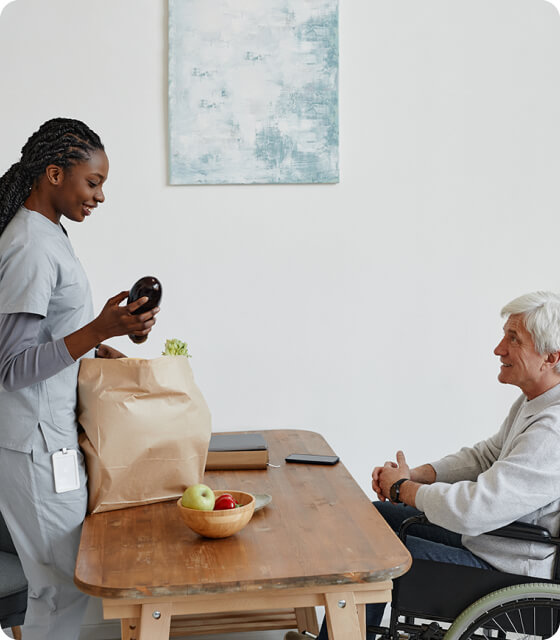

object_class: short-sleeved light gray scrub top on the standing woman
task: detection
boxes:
[0,207,94,453]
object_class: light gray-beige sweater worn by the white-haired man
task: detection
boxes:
[416,385,560,578]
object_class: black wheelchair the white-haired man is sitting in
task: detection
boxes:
[367,514,560,640]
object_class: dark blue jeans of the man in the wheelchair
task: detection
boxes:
[318,501,492,640]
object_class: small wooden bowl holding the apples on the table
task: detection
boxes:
[177,490,255,538]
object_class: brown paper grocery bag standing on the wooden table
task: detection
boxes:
[78,356,211,513]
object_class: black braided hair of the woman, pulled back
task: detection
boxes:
[0,118,104,235]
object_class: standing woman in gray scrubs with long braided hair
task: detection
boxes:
[0,118,159,640]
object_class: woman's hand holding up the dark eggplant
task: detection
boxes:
[92,291,159,342]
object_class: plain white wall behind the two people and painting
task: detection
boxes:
[0,0,560,636]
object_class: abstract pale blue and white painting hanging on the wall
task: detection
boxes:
[169,0,339,184]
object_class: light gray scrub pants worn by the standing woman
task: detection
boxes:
[0,427,89,640]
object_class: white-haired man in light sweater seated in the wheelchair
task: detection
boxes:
[286,291,560,640]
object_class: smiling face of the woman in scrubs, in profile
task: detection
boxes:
[52,149,109,222]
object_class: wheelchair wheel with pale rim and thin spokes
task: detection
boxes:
[444,583,560,640]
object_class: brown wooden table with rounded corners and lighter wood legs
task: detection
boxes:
[75,430,411,640]
